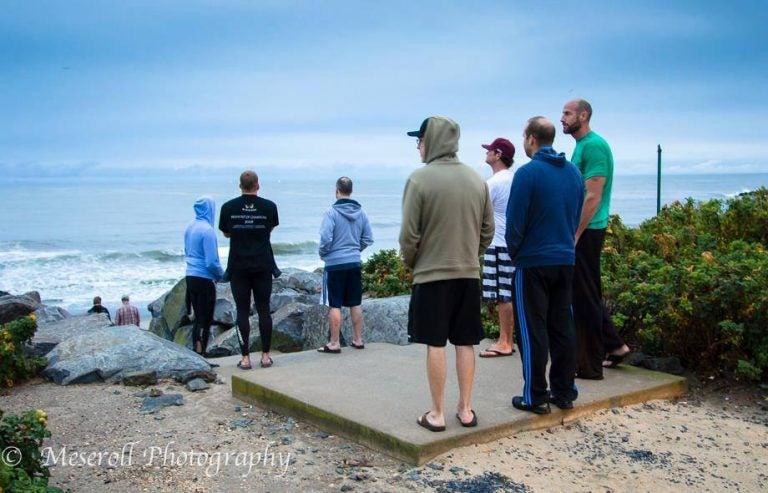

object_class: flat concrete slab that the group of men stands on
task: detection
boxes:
[232,341,686,465]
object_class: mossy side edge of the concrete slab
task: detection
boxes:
[232,365,687,466]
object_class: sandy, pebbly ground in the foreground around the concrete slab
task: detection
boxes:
[0,363,768,493]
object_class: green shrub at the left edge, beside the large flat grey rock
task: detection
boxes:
[0,314,45,387]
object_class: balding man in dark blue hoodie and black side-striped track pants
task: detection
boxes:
[505,116,584,414]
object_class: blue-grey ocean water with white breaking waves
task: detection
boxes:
[0,169,768,318]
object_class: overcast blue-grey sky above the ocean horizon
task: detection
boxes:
[0,0,768,175]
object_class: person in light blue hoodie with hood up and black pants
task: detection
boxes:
[184,196,224,355]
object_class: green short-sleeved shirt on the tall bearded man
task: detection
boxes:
[571,132,613,229]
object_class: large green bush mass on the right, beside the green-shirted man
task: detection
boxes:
[603,188,768,380]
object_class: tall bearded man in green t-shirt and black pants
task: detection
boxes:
[560,99,629,380]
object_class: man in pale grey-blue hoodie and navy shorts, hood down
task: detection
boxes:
[318,176,373,354]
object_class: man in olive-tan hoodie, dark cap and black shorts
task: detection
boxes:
[400,116,494,431]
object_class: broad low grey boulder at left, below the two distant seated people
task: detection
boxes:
[43,326,216,385]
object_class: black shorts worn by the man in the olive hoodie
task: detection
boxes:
[408,279,485,347]
